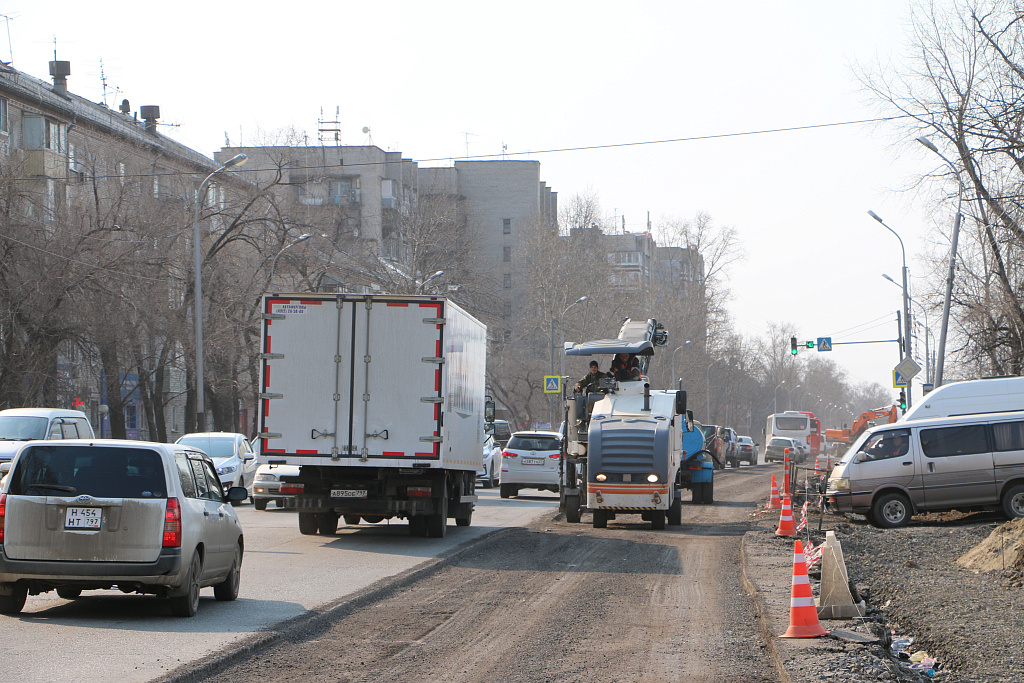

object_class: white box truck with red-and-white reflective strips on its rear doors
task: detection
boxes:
[257,294,494,538]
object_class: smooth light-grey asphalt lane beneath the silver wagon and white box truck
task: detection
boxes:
[0,489,557,683]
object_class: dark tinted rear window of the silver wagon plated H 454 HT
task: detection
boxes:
[8,445,167,498]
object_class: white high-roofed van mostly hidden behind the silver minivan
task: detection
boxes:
[900,377,1024,422]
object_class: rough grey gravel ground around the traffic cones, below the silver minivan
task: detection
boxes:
[748,513,1024,683]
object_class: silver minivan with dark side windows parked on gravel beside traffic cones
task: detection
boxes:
[825,412,1024,528]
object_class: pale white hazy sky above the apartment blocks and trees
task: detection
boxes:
[0,0,953,395]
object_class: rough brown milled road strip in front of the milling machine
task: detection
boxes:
[180,467,779,683]
